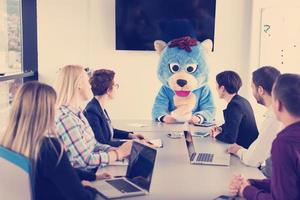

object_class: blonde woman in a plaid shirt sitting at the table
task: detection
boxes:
[56,65,132,171]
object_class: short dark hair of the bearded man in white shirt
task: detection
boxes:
[252,66,280,95]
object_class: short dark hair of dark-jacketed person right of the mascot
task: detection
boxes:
[216,71,242,94]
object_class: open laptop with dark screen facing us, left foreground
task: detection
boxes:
[93,142,156,199]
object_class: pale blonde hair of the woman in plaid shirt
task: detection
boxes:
[55,65,85,107]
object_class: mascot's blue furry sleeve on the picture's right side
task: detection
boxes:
[193,86,216,122]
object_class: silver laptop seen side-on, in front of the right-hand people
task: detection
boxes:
[184,131,230,166]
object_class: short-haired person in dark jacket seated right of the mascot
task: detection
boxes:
[211,71,258,149]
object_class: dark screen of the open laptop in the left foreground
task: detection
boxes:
[126,142,156,191]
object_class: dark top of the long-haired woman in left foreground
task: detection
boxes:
[34,138,96,200]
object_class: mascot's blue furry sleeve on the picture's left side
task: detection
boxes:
[152,87,170,121]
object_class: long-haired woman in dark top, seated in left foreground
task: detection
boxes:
[0,82,103,200]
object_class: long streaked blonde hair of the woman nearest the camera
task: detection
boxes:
[0,82,56,161]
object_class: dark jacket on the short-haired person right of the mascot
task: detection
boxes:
[216,95,258,149]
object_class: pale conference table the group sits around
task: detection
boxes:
[98,120,264,200]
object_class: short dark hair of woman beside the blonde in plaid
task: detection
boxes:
[90,69,115,96]
